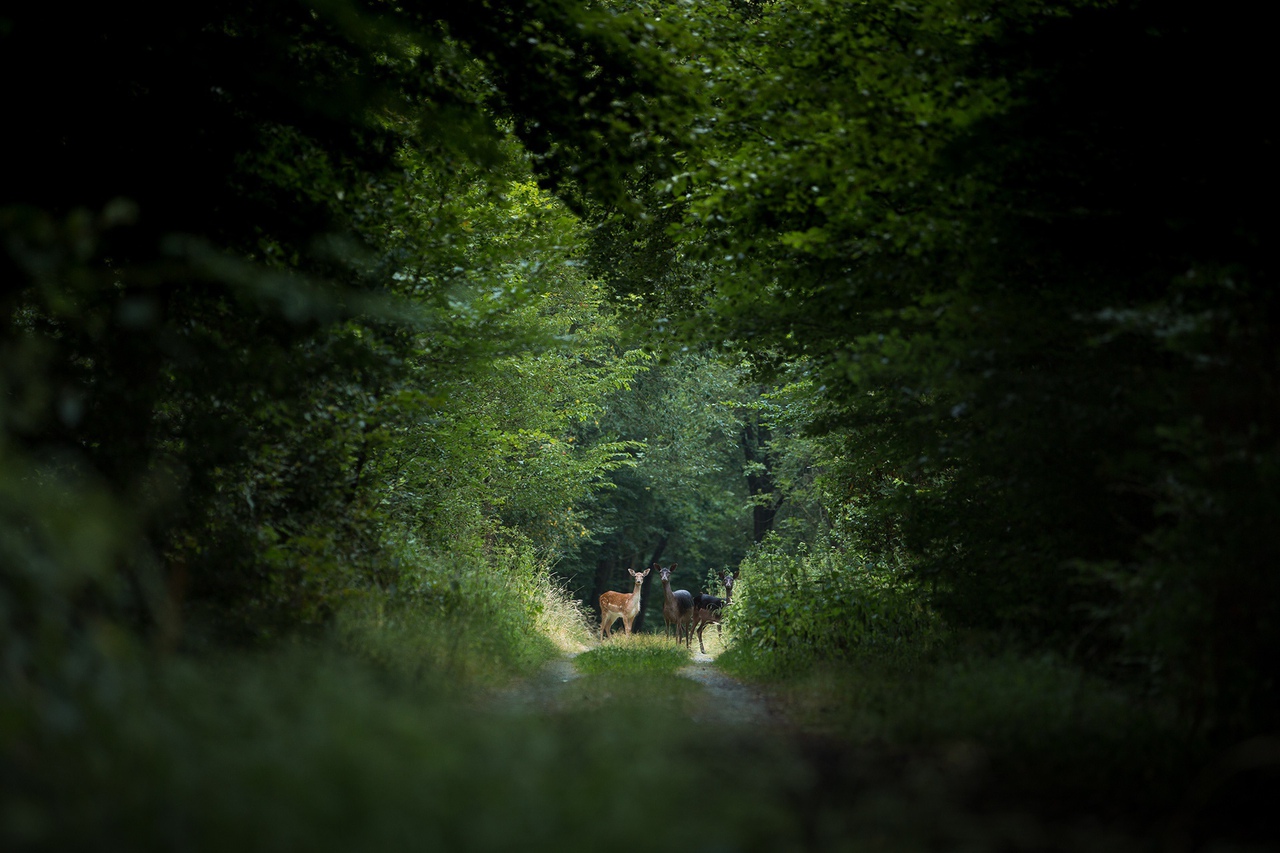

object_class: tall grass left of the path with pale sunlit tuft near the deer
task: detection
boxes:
[0,535,622,852]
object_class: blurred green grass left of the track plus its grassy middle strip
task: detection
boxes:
[0,638,800,853]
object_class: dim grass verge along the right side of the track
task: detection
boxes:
[722,637,1201,816]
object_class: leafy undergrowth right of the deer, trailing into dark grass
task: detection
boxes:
[717,542,1203,811]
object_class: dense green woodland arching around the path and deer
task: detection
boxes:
[0,0,1280,849]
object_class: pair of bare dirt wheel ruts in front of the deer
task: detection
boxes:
[483,647,1158,853]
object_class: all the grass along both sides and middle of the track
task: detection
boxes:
[0,545,1228,853]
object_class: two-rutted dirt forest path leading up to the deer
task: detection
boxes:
[486,646,1156,853]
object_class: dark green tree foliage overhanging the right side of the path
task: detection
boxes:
[664,0,1280,730]
